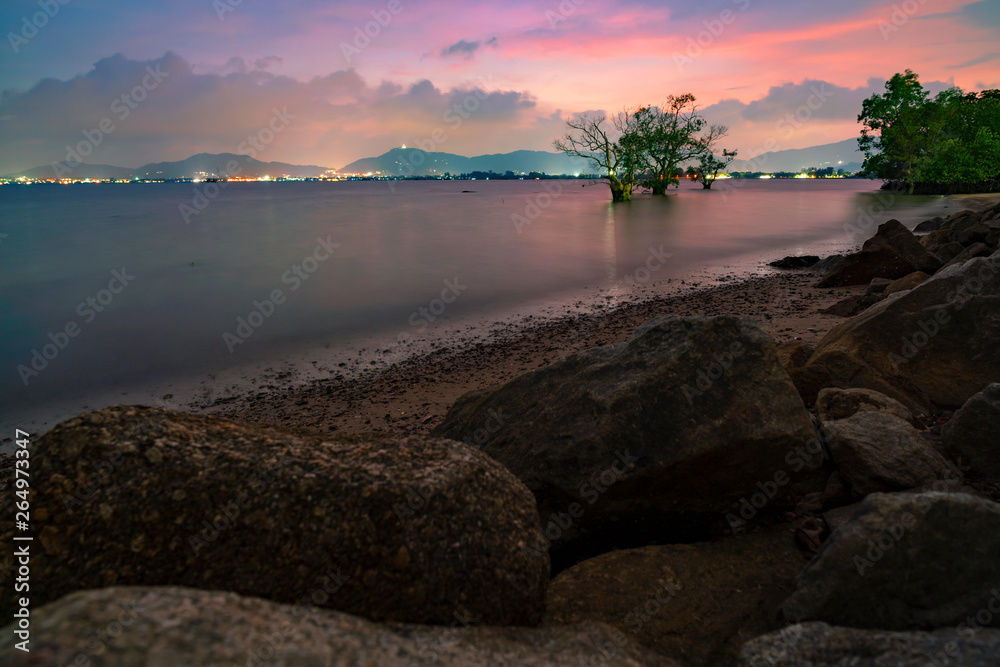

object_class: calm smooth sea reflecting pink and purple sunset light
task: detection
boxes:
[0,180,961,437]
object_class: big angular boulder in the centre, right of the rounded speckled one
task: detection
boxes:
[434,316,822,562]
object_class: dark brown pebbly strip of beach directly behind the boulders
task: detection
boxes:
[201,268,865,435]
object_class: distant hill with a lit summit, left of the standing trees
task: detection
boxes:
[340,148,594,176]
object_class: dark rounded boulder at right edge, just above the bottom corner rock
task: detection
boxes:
[783,491,1000,630]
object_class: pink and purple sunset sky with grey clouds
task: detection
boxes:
[0,0,1000,174]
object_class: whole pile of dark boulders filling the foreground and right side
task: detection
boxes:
[0,206,1000,667]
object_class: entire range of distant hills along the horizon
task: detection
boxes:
[4,139,864,179]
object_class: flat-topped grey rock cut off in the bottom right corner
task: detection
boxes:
[738,623,1000,667]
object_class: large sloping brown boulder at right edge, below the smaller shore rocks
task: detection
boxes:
[798,252,1000,412]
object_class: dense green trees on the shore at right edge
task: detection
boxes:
[858,70,1000,193]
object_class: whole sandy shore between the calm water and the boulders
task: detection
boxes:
[0,189,996,448]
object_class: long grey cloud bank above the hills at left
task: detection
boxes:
[0,52,545,173]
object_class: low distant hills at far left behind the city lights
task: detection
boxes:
[3,153,329,179]
